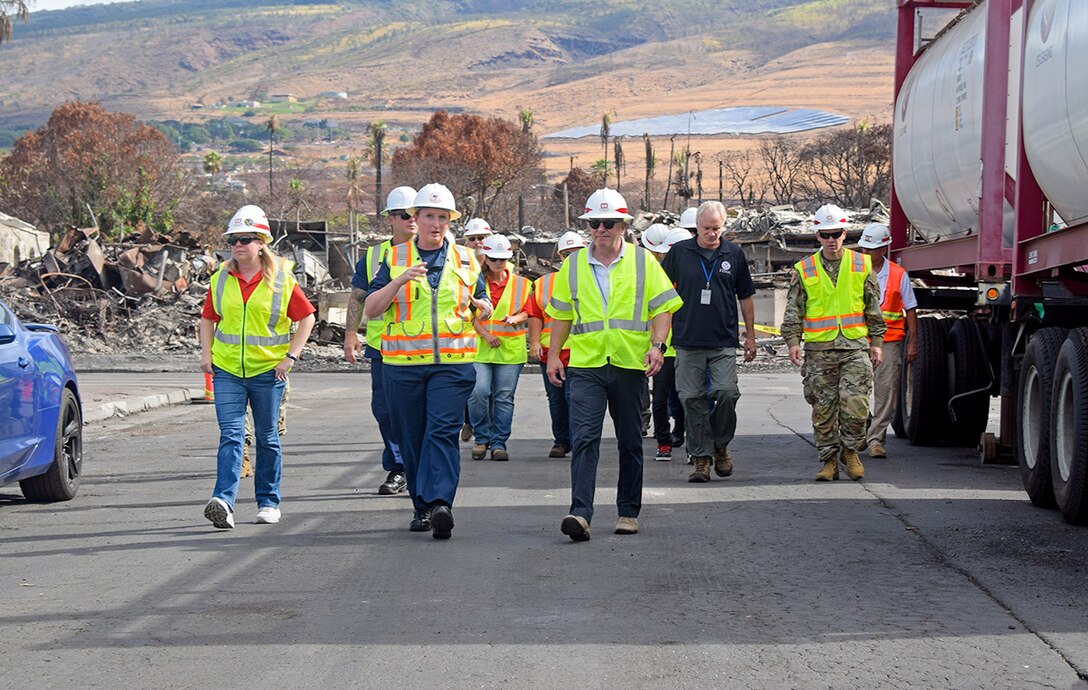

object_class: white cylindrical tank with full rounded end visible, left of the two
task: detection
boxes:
[892,2,1022,245]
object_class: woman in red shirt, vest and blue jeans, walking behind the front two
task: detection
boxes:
[469,234,532,460]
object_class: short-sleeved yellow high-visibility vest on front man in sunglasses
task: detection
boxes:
[547,243,683,371]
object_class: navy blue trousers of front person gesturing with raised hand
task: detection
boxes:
[384,365,475,510]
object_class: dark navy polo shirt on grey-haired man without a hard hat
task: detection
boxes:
[662,238,755,348]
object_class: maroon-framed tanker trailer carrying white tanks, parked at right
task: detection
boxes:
[892,0,1088,523]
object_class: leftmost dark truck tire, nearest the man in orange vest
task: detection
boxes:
[900,317,949,445]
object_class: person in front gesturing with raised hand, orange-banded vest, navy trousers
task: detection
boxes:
[366,183,492,539]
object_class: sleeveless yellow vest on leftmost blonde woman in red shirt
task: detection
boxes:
[211,260,295,379]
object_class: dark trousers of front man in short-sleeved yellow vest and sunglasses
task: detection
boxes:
[567,365,646,521]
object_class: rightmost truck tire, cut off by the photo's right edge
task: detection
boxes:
[1050,328,1088,525]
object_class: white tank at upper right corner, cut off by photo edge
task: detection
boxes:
[1024,0,1088,224]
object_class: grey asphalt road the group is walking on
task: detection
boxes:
[0,371,1088,688]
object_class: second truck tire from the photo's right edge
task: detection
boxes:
[1016,329,1068,508]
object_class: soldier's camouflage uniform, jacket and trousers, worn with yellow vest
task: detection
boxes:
[782,251,886,463]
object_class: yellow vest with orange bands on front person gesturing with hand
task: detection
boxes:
[382,242,480,365]
